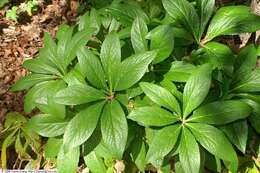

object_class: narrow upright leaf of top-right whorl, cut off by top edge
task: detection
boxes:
[196,0,215,34]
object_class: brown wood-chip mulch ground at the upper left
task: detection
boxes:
[0,0,79,120]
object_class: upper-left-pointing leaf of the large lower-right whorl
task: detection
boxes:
[140,82,181,115]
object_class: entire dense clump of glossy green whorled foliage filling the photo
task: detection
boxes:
[12,0,260,173]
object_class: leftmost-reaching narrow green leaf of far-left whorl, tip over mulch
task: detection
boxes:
[12,74,57,91]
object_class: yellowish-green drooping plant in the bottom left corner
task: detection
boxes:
[0,113,42,169]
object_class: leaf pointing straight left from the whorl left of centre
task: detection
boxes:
[54,84,106,105]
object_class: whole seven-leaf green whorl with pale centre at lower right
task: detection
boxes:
[128,64,251,172]
